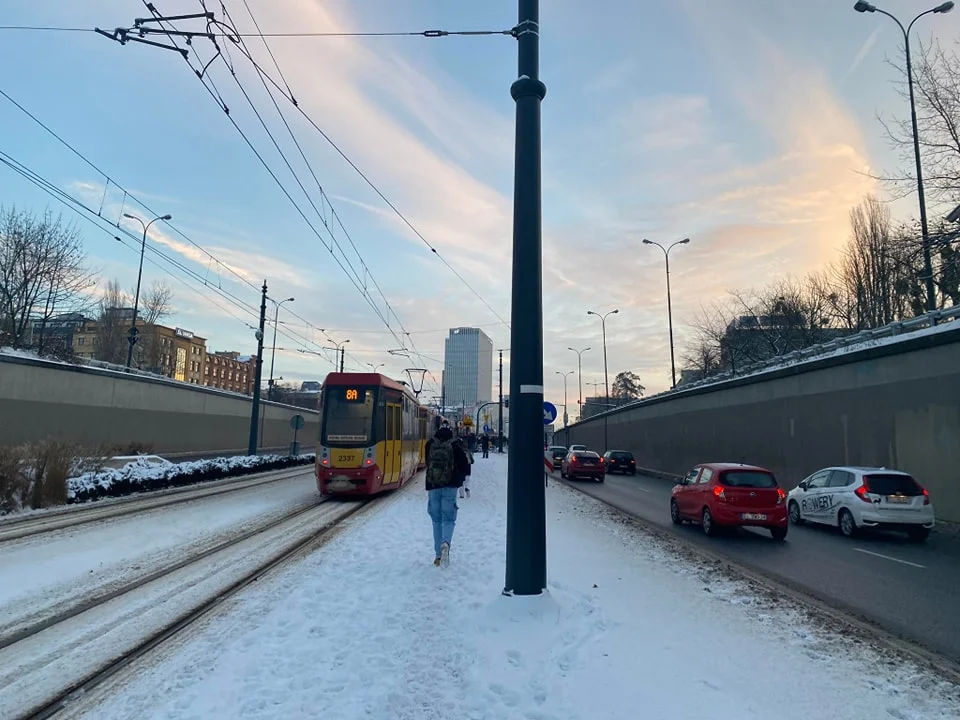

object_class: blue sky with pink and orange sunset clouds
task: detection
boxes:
[0,0,960,416]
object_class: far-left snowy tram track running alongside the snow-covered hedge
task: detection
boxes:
[0,465,313,543]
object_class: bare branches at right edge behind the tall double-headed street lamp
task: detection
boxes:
[880,40,960,203]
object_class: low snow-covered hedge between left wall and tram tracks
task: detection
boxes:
[67,455,316,503]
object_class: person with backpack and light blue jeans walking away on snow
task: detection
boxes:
[426,426,469,567]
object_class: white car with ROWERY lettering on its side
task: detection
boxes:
[787,467,935,542]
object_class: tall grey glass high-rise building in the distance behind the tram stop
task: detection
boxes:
[443,328,493,407]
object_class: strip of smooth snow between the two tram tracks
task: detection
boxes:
[0,467,318,635]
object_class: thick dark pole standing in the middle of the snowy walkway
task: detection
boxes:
[503,0,547,595]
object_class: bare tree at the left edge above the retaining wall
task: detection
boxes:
[0,208,96,347]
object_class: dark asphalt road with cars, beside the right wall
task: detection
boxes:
[554,466,960,662]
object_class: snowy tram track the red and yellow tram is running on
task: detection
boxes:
[0,499,376,719]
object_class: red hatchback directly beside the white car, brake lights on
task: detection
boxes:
[670,463,787,540]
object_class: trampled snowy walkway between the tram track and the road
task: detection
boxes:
[66,455,960,720]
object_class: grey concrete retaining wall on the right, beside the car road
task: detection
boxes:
[555,323,960,522]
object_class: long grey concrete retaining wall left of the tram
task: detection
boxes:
[0,355,319,455]
